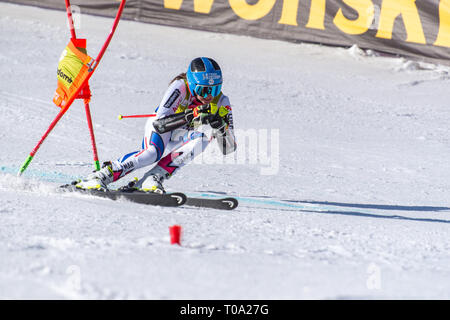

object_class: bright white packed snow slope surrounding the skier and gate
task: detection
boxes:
[0,3,450,299]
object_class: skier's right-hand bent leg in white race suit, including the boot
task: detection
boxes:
[135,128,211,193]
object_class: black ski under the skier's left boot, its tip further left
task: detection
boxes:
[61,184,187,207]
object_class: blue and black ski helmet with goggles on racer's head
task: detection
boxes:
[186,57,222,98]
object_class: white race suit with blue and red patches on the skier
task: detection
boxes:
[105,79,236,181]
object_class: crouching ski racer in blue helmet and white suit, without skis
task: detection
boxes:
[75,57,236,194]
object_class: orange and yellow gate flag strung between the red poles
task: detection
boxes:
[53,39,96,109]
